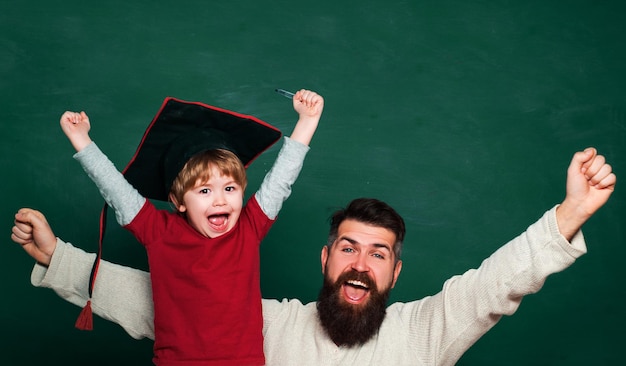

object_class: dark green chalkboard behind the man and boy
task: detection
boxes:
[0,0,626,365]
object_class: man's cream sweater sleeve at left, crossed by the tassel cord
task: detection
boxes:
[31,239,154,339]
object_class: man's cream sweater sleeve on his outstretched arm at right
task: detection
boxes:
[398,207,587,365]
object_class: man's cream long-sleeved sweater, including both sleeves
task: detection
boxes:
[31,207,586,366]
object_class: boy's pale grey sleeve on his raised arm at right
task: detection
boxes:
[255,137,310,220]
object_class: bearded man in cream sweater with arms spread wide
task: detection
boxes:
[12,148,616,366]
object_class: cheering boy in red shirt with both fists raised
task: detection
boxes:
[61,89,324,365]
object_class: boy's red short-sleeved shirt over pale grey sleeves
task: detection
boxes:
[126,196,274,365]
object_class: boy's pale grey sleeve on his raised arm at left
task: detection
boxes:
[74,142,146,226]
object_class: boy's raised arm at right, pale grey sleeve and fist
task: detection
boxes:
[255,89,324,220]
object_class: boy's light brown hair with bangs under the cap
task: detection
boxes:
[170,149,248,205]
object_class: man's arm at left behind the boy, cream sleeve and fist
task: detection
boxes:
[11,208,154,339]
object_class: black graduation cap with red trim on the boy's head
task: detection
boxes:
[124,97,282,201]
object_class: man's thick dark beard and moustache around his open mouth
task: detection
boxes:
[317,271,391,347]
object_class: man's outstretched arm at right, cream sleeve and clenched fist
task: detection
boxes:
[402,148,616,364]
